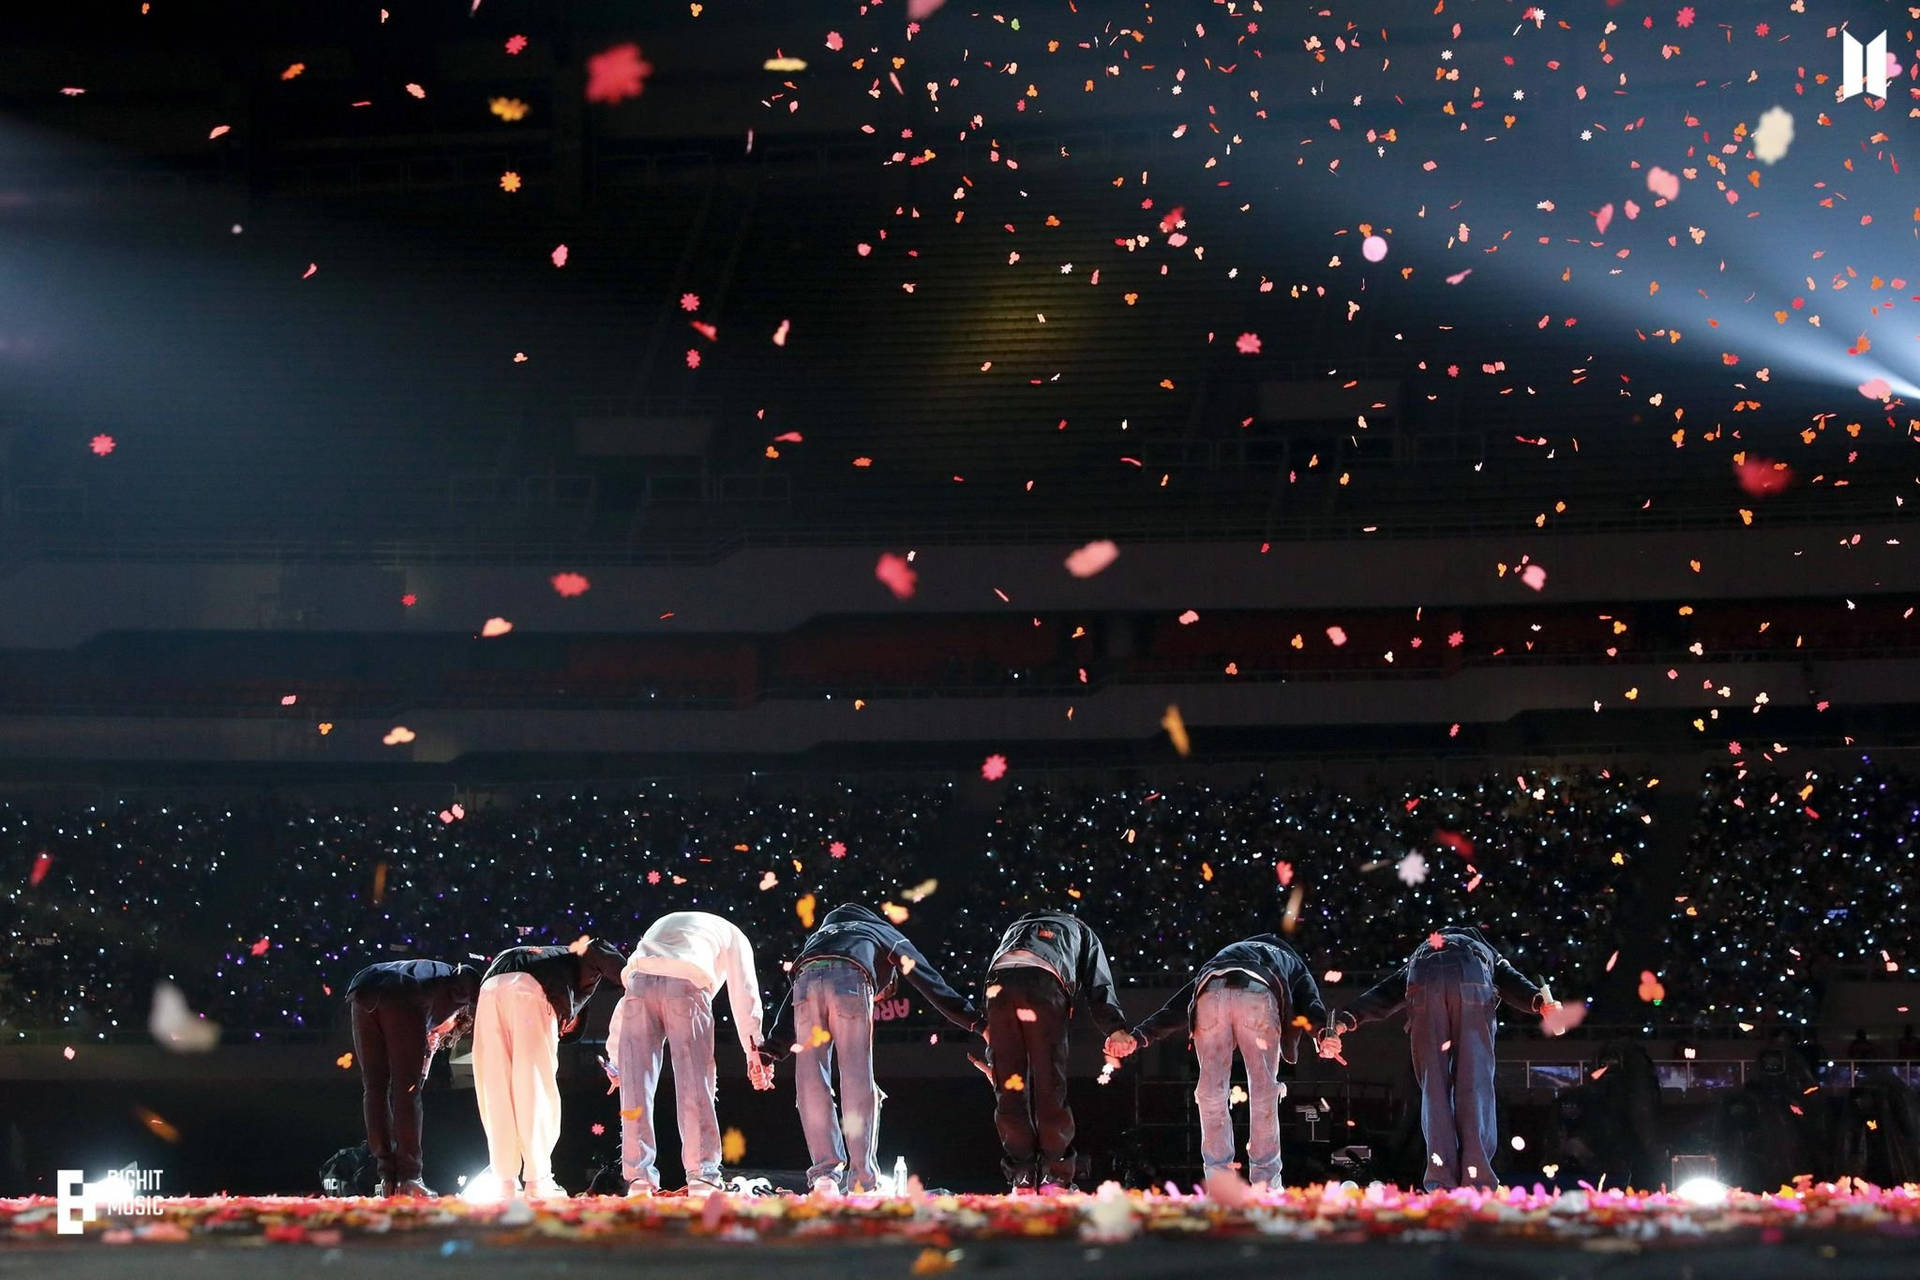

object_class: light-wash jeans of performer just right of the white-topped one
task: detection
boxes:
[793,960,883,1192]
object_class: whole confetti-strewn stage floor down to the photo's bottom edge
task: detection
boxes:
[0,1186,1920,1280]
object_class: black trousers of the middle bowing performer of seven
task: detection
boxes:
[987,967,1073,1184]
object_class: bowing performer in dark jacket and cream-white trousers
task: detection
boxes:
[474,938,626,1199]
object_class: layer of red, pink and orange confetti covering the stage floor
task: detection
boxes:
[0,1184,1920,1251]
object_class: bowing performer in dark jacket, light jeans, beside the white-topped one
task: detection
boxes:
[768,904,983,1192]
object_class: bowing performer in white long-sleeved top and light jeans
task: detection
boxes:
[607,912,774,1196]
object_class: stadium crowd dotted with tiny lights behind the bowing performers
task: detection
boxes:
[0,764,1920,1034]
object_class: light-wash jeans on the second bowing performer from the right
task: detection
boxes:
[1194,983,1283,1188]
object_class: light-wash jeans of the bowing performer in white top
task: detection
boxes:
[614,973,720,1190]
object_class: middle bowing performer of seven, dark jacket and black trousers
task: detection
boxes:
[987,912,1127,1192]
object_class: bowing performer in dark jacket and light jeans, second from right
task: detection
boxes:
[1106,933,1327,1190]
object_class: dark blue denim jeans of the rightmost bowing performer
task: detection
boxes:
[1407,946,1500,1192]
